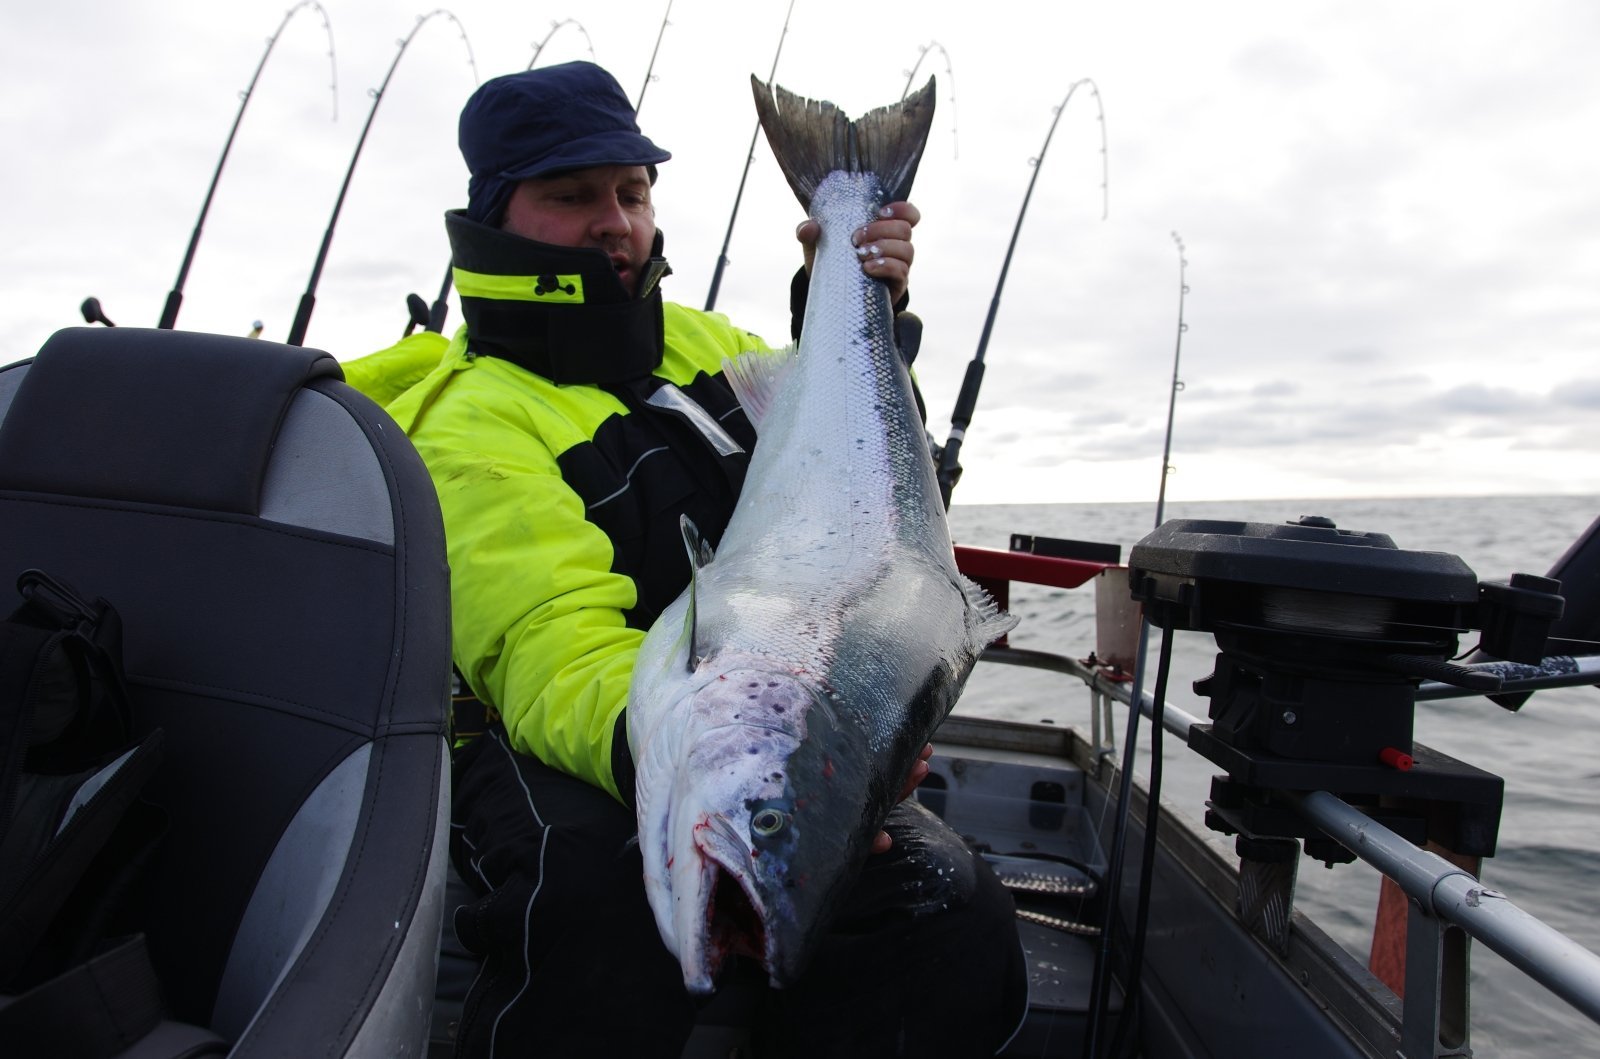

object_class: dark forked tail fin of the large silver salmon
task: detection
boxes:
[750,75,934,210]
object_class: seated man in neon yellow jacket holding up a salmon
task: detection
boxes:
[347,62,1026,1057]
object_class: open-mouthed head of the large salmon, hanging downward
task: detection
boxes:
[640,667,877,993]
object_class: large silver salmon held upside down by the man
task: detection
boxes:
[627,78,1014,992]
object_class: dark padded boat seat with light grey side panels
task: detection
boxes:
[0,328,450,1057]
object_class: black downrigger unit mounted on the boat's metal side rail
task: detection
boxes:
[1128,515,1563,865]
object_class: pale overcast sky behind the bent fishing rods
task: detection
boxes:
[0,0,1600,502]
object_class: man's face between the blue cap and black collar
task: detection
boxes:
[501,165,656,294]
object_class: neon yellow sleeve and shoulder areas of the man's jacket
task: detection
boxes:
[344,302,768,798]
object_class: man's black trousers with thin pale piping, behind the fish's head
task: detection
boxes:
[451,726,1027,1059]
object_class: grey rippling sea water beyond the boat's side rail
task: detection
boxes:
[950,496,1600,1056]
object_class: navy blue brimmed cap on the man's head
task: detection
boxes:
[459,62,672,224]
